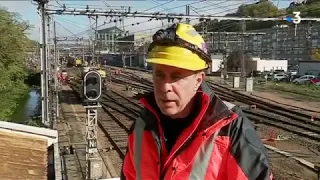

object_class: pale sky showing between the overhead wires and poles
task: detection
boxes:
[0,0,292,40]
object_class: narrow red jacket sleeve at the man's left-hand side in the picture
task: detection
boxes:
[120,123,136,180]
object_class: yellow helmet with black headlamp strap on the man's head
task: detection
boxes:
[147,23,211,71]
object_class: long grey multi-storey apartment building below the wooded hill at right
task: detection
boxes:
[203,24,320,65]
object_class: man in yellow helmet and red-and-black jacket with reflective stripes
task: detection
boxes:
[121,23,272,180]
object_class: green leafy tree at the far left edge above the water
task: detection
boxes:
[0,7,31,120]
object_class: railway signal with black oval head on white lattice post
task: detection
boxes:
[82,71,102,180]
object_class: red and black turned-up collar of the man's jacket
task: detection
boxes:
[140,82,231,131]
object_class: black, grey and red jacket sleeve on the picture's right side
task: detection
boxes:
[226,107,273,180]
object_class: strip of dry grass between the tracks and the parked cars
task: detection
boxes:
[254,82,320,99]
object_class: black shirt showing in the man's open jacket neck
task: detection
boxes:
[159,97,200,152]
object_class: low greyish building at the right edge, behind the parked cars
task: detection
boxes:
[298,61,320,76]
